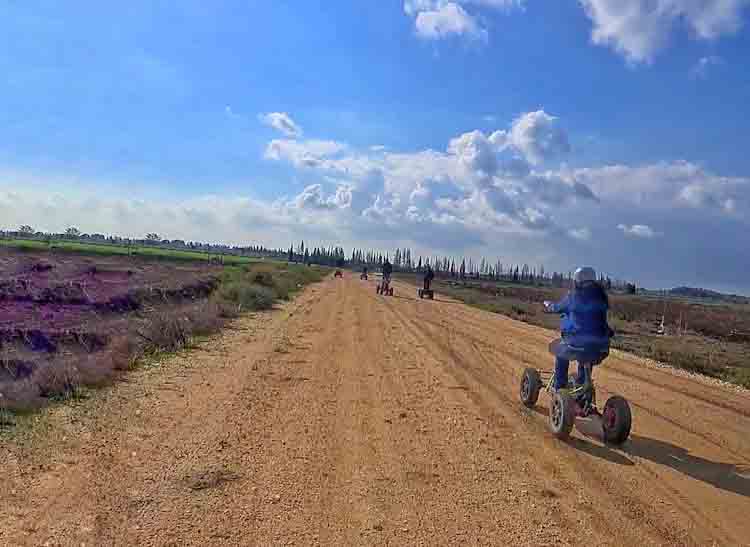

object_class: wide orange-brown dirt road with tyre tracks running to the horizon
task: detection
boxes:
[0,276,750,546]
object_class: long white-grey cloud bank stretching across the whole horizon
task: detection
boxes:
[5,107,750,291]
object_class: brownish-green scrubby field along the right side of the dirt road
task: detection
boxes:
[399,274,750,388]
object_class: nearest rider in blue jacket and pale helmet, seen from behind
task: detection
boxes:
[544,267,614,390]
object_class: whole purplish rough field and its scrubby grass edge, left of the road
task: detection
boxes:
[0,249,325,414]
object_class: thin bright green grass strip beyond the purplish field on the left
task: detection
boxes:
[0,239,260,265]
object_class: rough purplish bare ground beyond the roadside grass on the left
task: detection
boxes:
[0,248,223,414]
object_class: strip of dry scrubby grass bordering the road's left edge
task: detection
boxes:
[0,263,325,414]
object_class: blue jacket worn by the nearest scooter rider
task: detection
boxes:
[550,283,612,349]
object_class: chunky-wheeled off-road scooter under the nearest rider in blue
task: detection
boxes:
[520,339,631,445]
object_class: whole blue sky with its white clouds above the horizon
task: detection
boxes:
[0,0,750,292]
